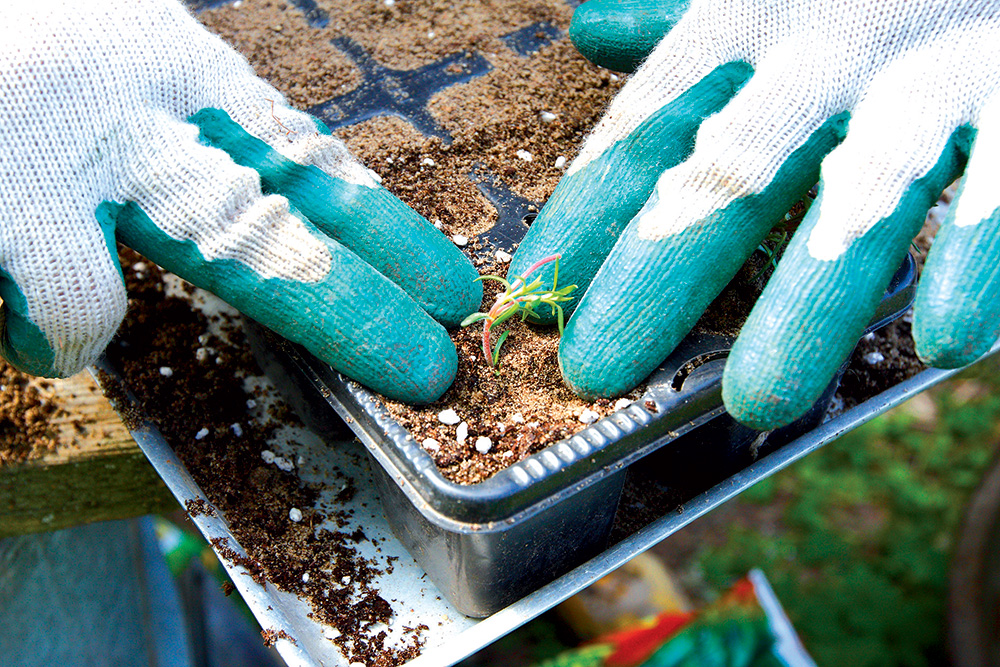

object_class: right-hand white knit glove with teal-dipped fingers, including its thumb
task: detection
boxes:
[510,0,1000,429]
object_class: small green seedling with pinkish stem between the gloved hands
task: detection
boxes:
[462,255,576,368]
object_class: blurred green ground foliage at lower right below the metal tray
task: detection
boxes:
[696,359,1000,667]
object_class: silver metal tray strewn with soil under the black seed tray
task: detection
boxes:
[92,344,1000,667]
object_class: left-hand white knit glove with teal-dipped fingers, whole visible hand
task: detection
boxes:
[0,0,482,402]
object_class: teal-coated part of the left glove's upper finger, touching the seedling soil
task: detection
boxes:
[190,109,483,326]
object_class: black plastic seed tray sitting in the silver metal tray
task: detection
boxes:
[250,190,916,617]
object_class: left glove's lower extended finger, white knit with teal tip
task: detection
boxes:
[111,114,457,403]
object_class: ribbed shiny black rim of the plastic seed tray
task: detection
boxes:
[254,254,916,533]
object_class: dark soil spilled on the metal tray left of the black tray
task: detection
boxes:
[102,249,422,665]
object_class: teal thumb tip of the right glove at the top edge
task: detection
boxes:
[569,0,691,72]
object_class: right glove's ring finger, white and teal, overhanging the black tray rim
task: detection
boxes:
[723,59,972,430]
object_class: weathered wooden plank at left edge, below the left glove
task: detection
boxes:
[0,373,177,538]
